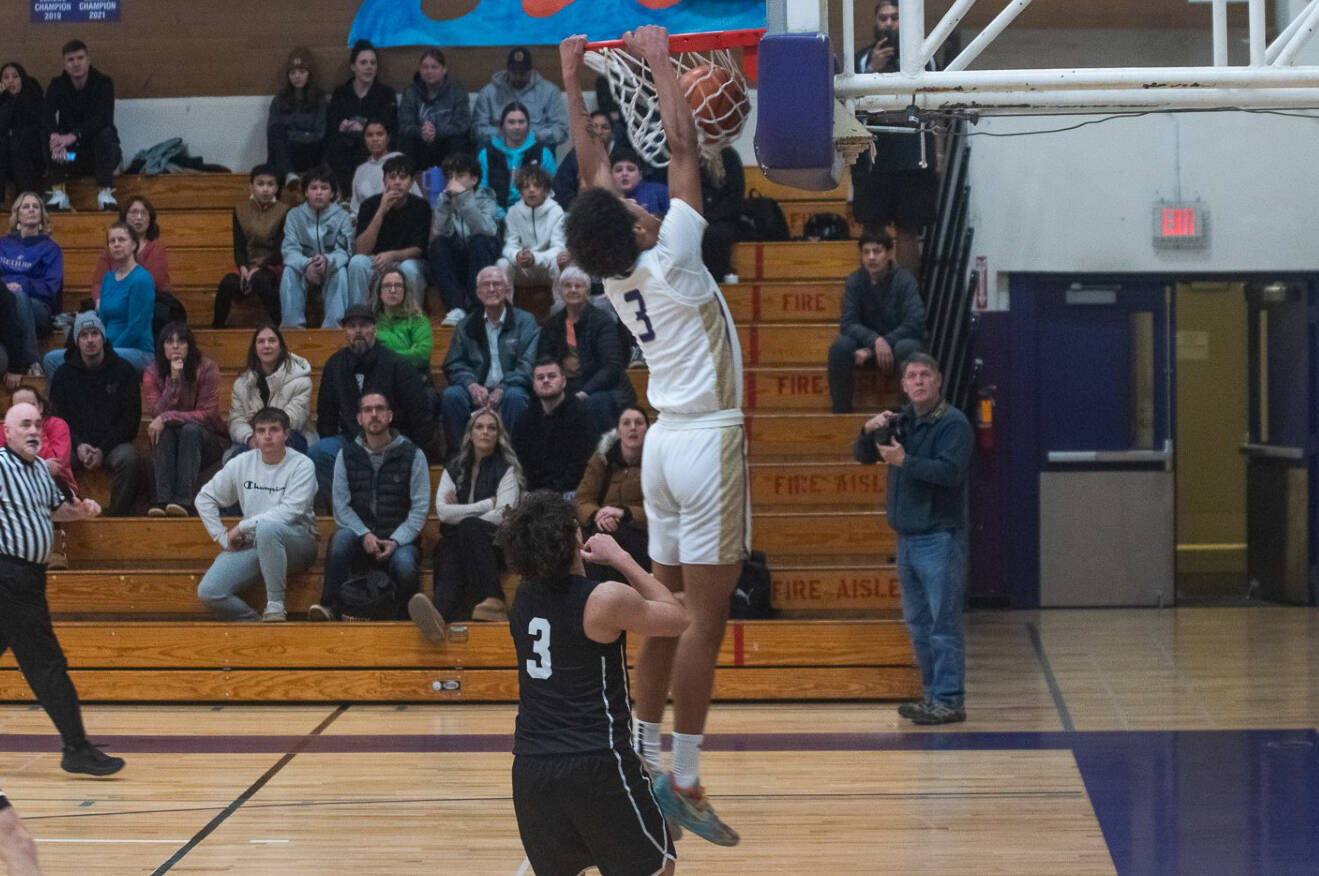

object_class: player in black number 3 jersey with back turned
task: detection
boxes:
[499,491,687,876]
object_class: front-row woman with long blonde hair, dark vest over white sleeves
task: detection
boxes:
[408,410,522,641]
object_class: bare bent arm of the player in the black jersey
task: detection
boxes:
[582,534,691,642]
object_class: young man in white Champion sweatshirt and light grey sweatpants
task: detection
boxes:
[197,408,317,621]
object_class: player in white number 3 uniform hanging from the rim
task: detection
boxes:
[559,25,749,846]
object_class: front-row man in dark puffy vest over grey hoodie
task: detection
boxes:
[307,392,430,620]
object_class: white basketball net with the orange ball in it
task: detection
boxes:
[586,47,751,168]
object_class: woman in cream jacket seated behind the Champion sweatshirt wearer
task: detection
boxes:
[227,322,311,459]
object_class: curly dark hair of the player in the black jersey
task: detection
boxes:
[495,489,578,586]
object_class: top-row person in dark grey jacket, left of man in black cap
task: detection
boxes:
[398,49,472,176]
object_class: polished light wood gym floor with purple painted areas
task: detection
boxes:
[0,607,1319,876]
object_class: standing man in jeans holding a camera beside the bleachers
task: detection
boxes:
[852,352,972,724]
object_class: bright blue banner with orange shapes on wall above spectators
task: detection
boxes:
[348,0,765,47]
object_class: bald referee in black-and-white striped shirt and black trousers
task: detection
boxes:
[0,404,124,776]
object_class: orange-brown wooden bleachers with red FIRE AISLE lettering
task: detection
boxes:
[0,168,919,702]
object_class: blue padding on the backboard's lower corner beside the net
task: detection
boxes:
[756,33,838,190]
